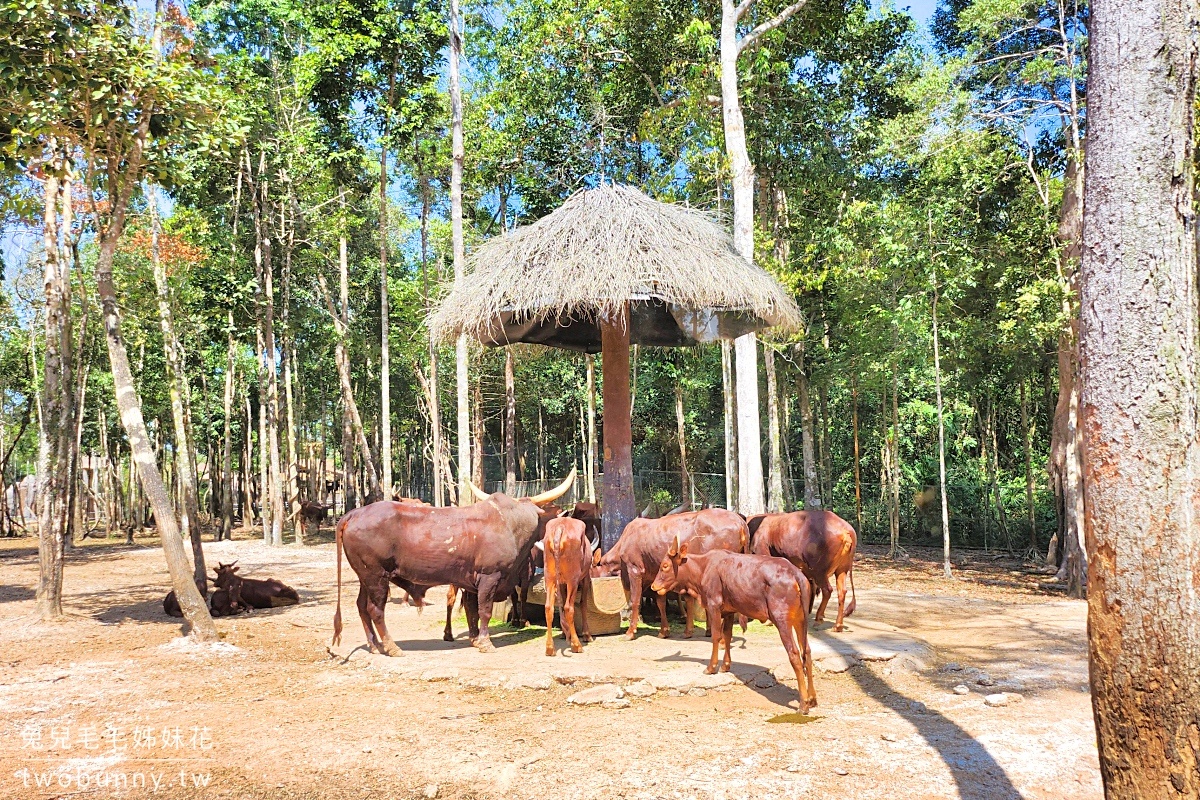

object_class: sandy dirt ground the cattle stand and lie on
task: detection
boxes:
[0,530,1102,800]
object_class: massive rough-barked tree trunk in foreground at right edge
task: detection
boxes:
[1080,0,1200,800]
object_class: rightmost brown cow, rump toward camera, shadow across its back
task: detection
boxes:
[749,510,858,632]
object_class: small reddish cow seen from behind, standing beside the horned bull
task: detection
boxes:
[535,517,595,656]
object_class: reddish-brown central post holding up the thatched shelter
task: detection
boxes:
[600,303,637,552]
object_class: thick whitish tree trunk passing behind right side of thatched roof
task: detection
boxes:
[720,0,766,515]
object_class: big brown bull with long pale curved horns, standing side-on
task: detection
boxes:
[334,470,575,656]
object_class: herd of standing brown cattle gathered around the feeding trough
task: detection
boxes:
[334,473,857,711]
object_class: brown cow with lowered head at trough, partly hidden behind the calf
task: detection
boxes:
[593,509,750,639]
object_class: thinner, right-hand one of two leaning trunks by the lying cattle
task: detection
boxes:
[146,186,209,593]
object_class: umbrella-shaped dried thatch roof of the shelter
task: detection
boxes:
[430,185,800,350]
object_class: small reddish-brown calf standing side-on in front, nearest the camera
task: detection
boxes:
[650,540,817,714]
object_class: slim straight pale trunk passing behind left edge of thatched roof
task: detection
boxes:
[449,0,474,505]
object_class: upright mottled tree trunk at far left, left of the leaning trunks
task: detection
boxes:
[36,161,74,621]
